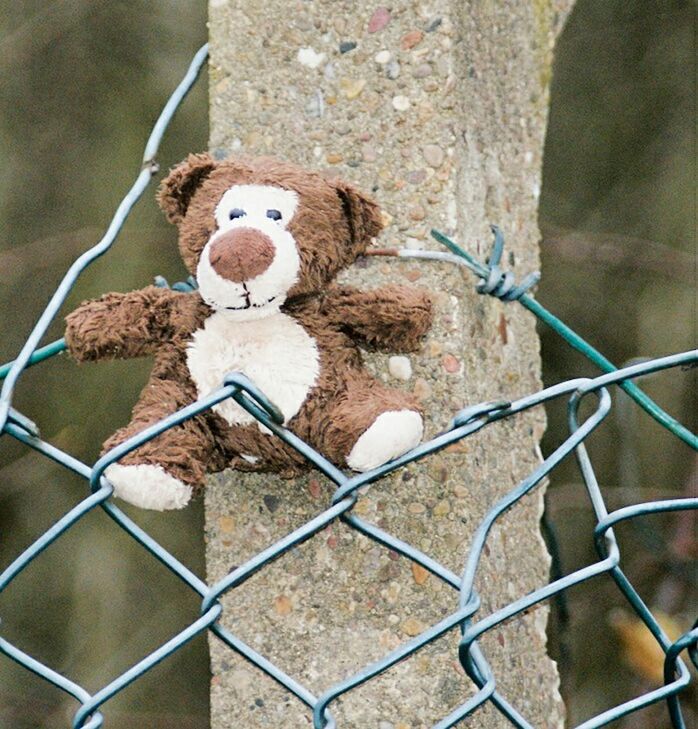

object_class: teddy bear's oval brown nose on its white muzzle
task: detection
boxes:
[208,228,276,283]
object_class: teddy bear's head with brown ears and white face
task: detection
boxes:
[159,154,382,319]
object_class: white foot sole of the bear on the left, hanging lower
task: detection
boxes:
[104,463,192,511]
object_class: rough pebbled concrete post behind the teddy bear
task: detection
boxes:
[206,0,572,729]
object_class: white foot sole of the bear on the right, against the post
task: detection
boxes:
[347,410,424,472]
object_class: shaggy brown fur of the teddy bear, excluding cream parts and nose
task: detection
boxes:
[66,154,431,498]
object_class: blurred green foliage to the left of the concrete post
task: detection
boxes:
[0,0,209,729]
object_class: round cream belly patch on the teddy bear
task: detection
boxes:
[182,311,320,432]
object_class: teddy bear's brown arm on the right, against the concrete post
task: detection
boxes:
[324,284,432,352]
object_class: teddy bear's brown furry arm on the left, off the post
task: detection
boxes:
[65,286,186,362]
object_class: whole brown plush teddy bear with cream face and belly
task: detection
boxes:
[66,154,431,510]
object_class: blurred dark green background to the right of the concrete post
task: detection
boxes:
[537,0,698,729]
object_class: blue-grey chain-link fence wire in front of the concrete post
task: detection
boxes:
[0,47,698,729]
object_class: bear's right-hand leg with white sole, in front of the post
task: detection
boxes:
[318,376,424,472]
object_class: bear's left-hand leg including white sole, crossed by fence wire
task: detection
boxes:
[102,377,215,511]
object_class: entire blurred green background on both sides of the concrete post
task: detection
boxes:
[0,0,698,729]
